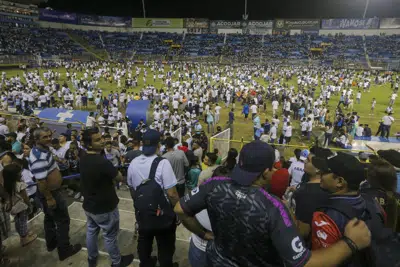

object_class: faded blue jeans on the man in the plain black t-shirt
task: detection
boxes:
[85,208,121,265]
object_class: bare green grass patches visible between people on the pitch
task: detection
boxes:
[6,69,400,157]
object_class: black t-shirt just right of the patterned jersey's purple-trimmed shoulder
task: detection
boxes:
[292,183,329,224]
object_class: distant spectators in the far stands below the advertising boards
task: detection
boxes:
[0,25,400,64]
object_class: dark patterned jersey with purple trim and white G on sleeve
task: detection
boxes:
[180,177,311,267]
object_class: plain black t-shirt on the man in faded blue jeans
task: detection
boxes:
[80,154,119,214]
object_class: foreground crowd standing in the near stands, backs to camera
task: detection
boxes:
[0,119,400,267]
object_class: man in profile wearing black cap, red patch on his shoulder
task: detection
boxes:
[311,152,384,266]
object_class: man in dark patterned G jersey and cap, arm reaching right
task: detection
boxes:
[175,141,370,267]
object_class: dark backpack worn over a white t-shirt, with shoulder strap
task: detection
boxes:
[133,157,176,230]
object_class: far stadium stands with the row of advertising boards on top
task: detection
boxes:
[0,1,400,70]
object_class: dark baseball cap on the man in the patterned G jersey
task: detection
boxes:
[231,140,275,186]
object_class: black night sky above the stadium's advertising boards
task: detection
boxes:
[42,0,400,20]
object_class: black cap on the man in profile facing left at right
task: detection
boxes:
[312,152,366,186]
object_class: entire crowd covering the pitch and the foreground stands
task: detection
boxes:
[0,55,400,267]
